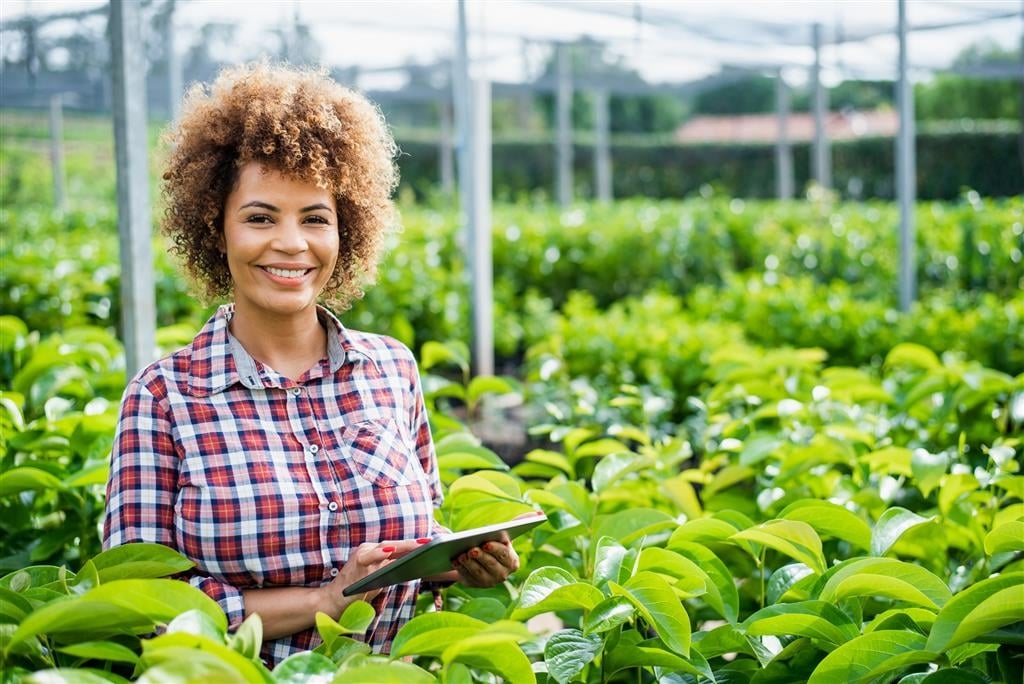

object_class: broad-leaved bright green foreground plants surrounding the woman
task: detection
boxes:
[0,317,1024,684]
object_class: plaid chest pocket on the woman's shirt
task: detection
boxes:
[339,418,419,487]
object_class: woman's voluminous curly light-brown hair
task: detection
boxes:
[162,62,398,309]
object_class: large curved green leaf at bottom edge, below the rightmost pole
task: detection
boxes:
[808,630,937,684]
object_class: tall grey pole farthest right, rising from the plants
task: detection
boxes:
[896,0,918,311]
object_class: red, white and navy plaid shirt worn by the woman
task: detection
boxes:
[103,305,441,667]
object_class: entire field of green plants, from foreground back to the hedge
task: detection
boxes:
[0,109,1024,684]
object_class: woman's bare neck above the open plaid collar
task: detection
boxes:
[229,303,327,380]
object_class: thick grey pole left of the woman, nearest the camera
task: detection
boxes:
[111,0,156,378]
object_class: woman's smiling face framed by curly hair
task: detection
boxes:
[223,162,339,323]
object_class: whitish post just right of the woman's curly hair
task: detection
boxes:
[471,79,495,375]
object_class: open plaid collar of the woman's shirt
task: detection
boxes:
[188,304,378,396]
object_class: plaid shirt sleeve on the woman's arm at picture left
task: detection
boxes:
[103,380,245,629]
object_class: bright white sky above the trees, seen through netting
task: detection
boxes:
[0,0,1024,89]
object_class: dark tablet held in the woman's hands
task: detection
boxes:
[342,511,548,596]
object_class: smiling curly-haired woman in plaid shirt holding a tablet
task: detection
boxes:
[103,63,518,667]
